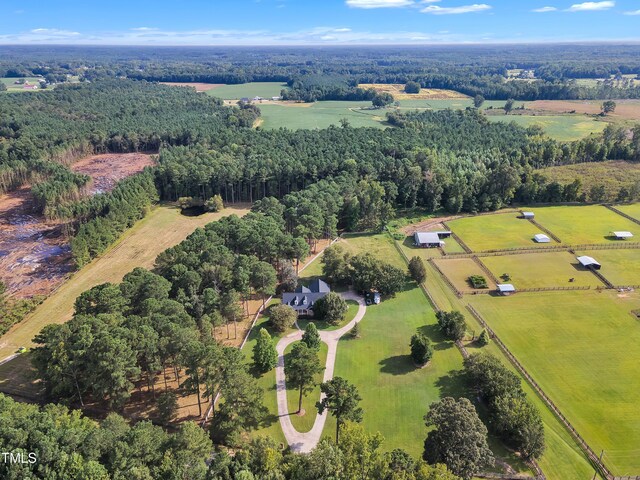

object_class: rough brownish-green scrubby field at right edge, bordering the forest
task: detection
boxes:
[538,160,640,201]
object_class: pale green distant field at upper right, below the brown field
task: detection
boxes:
[488,115,607,142]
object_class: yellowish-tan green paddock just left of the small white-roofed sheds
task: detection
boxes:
[480,250,604,289]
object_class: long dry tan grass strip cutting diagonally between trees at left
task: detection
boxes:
[0,205,249,360]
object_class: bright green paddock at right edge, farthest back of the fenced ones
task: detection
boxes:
[531,205,640,245]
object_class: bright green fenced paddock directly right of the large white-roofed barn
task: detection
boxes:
[448,212,542,252]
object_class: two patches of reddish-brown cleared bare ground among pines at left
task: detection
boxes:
[0,153,154,298]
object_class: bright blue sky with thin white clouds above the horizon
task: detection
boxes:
[0,0,640,45]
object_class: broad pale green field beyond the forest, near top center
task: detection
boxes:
[258,101,387,130]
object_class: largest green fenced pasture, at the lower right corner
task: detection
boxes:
[470,291,640,475]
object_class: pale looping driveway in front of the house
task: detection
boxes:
[276,292,366,453]
